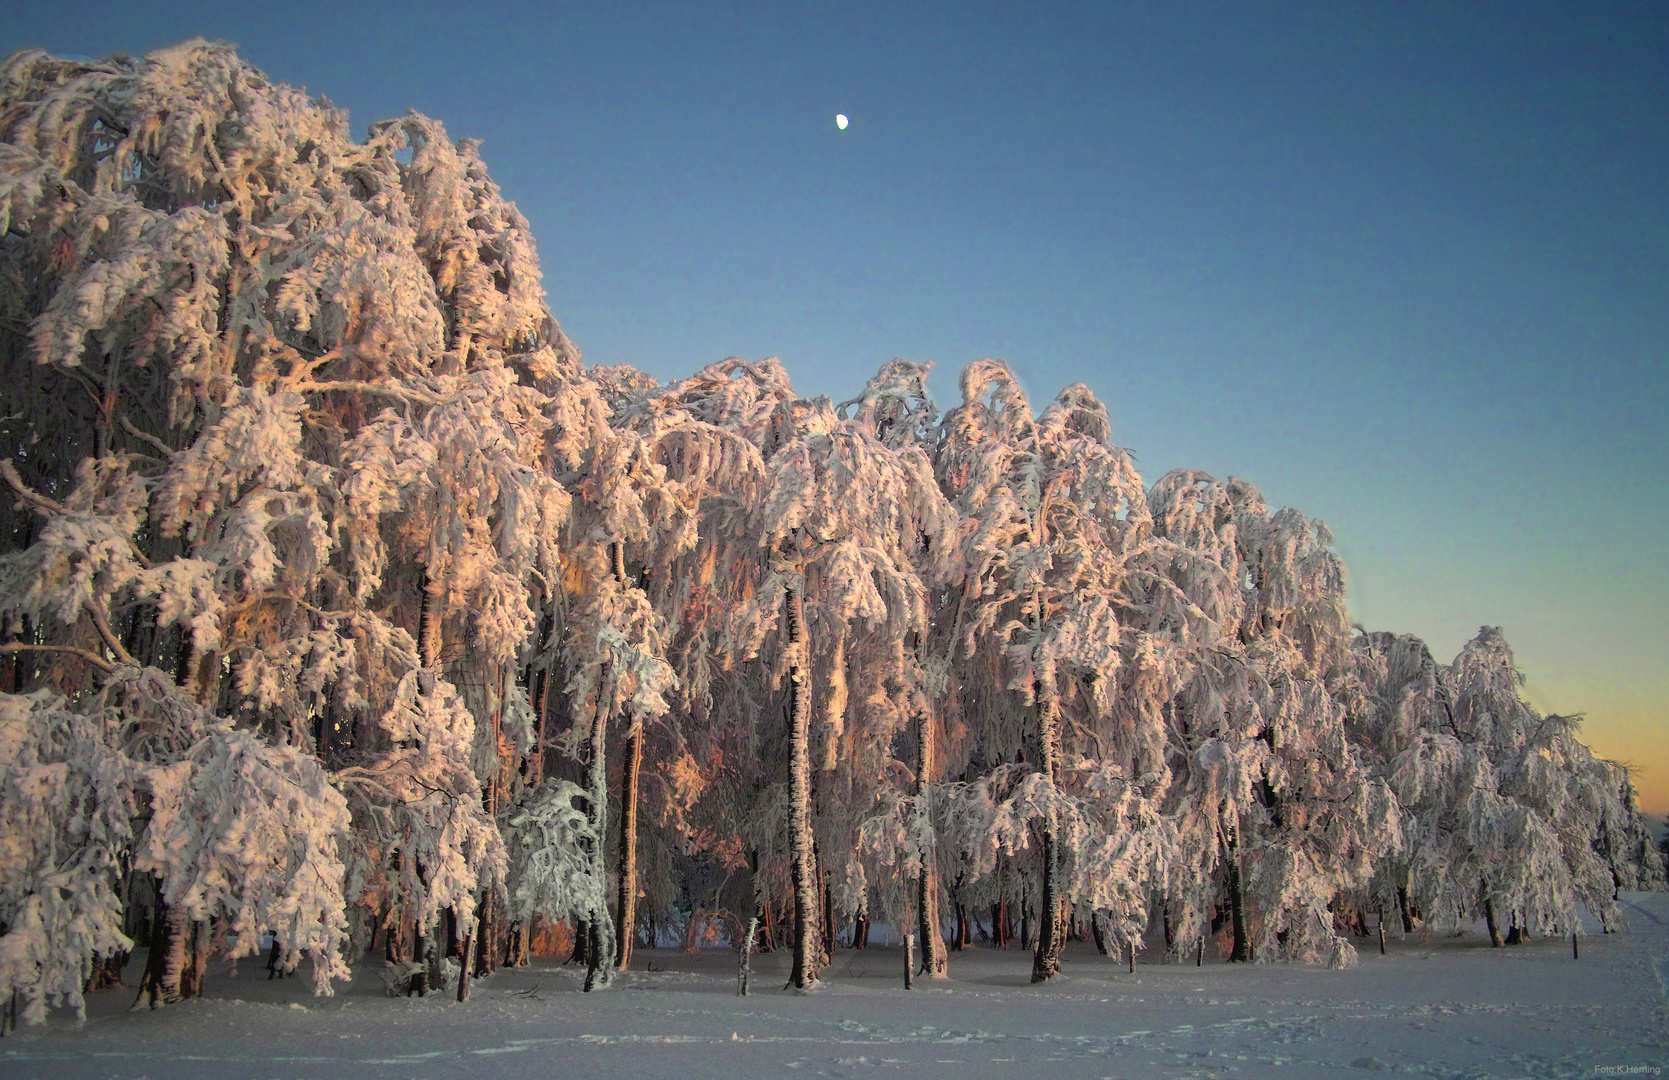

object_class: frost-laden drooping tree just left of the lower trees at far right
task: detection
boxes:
[1148,471,1400,965]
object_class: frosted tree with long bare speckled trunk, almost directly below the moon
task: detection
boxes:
[726,378,956,988]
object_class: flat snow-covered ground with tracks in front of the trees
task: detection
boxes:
[0,893,1669,1080]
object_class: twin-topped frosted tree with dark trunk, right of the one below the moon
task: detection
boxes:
[938,361,1167,982]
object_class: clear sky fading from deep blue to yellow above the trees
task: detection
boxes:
[13,0,1669,815]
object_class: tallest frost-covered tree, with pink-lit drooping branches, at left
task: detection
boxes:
[0,42,577,1014]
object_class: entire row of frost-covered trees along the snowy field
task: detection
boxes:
[0,42,1664,1022]
